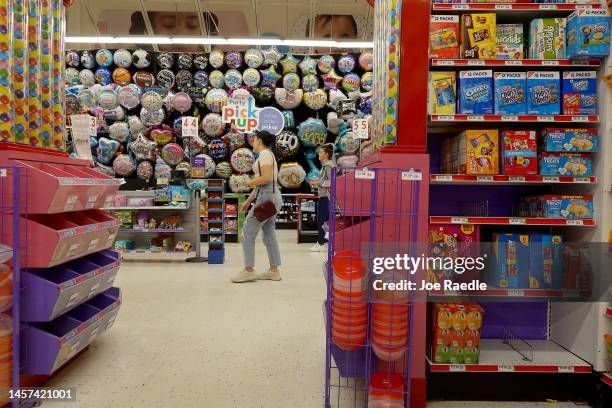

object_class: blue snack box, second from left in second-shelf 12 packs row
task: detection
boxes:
[494,72,527,115]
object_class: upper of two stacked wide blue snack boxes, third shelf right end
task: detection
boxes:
[542,128,599,153]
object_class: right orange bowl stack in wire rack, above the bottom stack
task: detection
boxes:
[372,303,408,361]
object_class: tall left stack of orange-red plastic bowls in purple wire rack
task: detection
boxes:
[331,251,368,350]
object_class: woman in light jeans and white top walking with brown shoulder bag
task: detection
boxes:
[232,131,282,283]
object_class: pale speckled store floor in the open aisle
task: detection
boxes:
[45,231,584,408]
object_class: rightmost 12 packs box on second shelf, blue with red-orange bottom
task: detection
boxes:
[562,71,598,115]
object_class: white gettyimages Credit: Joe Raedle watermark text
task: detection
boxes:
[372,254,487,292]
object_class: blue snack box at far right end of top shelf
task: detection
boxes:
[567,9,610,59]
